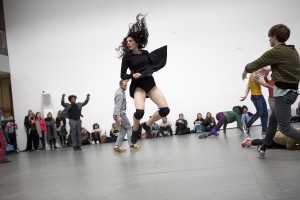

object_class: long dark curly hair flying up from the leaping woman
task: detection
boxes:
[116,13,149,58]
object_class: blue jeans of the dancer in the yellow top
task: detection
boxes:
[247,95,268,132]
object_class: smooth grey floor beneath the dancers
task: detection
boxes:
[0,124,300,200]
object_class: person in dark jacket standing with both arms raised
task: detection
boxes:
[61,94,90,151]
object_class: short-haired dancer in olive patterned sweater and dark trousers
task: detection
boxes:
[242,24,300,158]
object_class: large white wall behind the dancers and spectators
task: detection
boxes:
[4,0,300,149]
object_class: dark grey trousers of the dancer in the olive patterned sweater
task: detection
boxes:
[264,91,300,146]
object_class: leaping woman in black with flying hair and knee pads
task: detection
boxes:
[117,14,170,144]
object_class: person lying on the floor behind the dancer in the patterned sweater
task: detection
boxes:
[242,129,300,150]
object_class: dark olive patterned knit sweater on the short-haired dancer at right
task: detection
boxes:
[245,44,300,89]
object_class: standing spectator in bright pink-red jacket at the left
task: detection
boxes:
[34,112,47,150]
